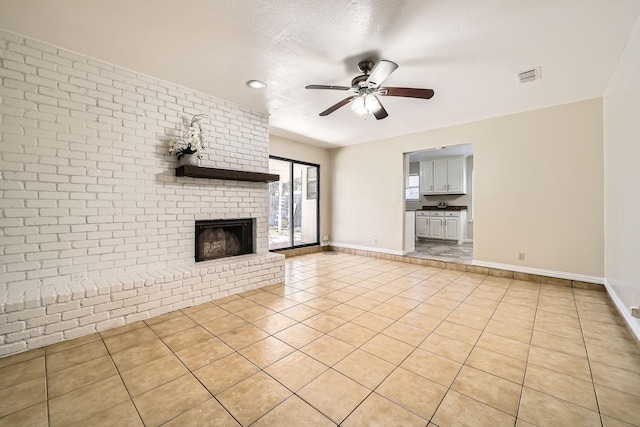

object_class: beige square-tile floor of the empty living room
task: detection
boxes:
[0,253,640,427]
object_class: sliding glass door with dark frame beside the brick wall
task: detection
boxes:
[269,157,320,250]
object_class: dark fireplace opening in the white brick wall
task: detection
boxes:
[196,218,254,262]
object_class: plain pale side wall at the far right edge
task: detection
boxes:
[604,15,640,332]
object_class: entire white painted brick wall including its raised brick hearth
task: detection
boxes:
[0,30,284,355]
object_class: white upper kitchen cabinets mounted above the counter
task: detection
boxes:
[420,157,467,195]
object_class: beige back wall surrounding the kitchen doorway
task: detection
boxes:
[331,98,604,277]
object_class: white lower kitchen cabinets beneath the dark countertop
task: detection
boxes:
[416,210,467,243]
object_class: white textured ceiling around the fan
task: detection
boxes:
[0,0,640,145]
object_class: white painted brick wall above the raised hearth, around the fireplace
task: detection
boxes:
[0,32,269,289]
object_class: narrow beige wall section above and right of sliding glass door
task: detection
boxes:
[269,135,332,246]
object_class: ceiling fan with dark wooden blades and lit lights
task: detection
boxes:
[305,60,434,120]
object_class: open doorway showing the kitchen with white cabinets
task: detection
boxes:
[404,144,474,264]
